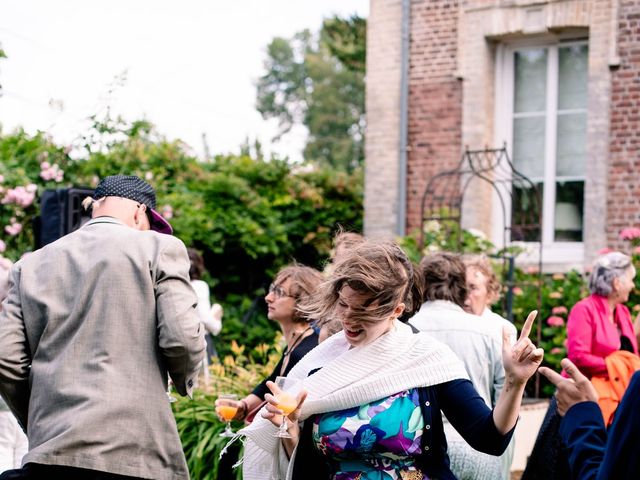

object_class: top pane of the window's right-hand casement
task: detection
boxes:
[558,45,588,110]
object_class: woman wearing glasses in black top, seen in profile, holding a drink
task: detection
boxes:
[216,265,323,422]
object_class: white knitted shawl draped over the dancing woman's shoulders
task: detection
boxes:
[241,321,468,480]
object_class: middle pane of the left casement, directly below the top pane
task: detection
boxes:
[513,117,545,180]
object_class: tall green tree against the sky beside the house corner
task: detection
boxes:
[257,17,366,171]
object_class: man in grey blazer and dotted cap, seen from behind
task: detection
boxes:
[0,175,205,480]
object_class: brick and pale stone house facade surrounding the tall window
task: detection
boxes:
[365,0,640,269]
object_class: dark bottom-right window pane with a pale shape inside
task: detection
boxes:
[553,182,584,242]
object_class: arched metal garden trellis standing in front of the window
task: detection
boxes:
[419,145,542,397]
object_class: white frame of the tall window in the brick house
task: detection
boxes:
[492,38,588,270]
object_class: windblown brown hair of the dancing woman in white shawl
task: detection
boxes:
[298,241,416,326]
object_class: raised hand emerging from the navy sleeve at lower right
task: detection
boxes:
[538,358,598,416]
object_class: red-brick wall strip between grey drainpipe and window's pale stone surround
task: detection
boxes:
[407,0,462,236]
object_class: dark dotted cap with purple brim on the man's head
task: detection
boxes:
[93,175,173,235]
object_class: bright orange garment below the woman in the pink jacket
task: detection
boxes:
[591,350,640,426]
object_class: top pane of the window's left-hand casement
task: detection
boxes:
[513,48,547,113]
